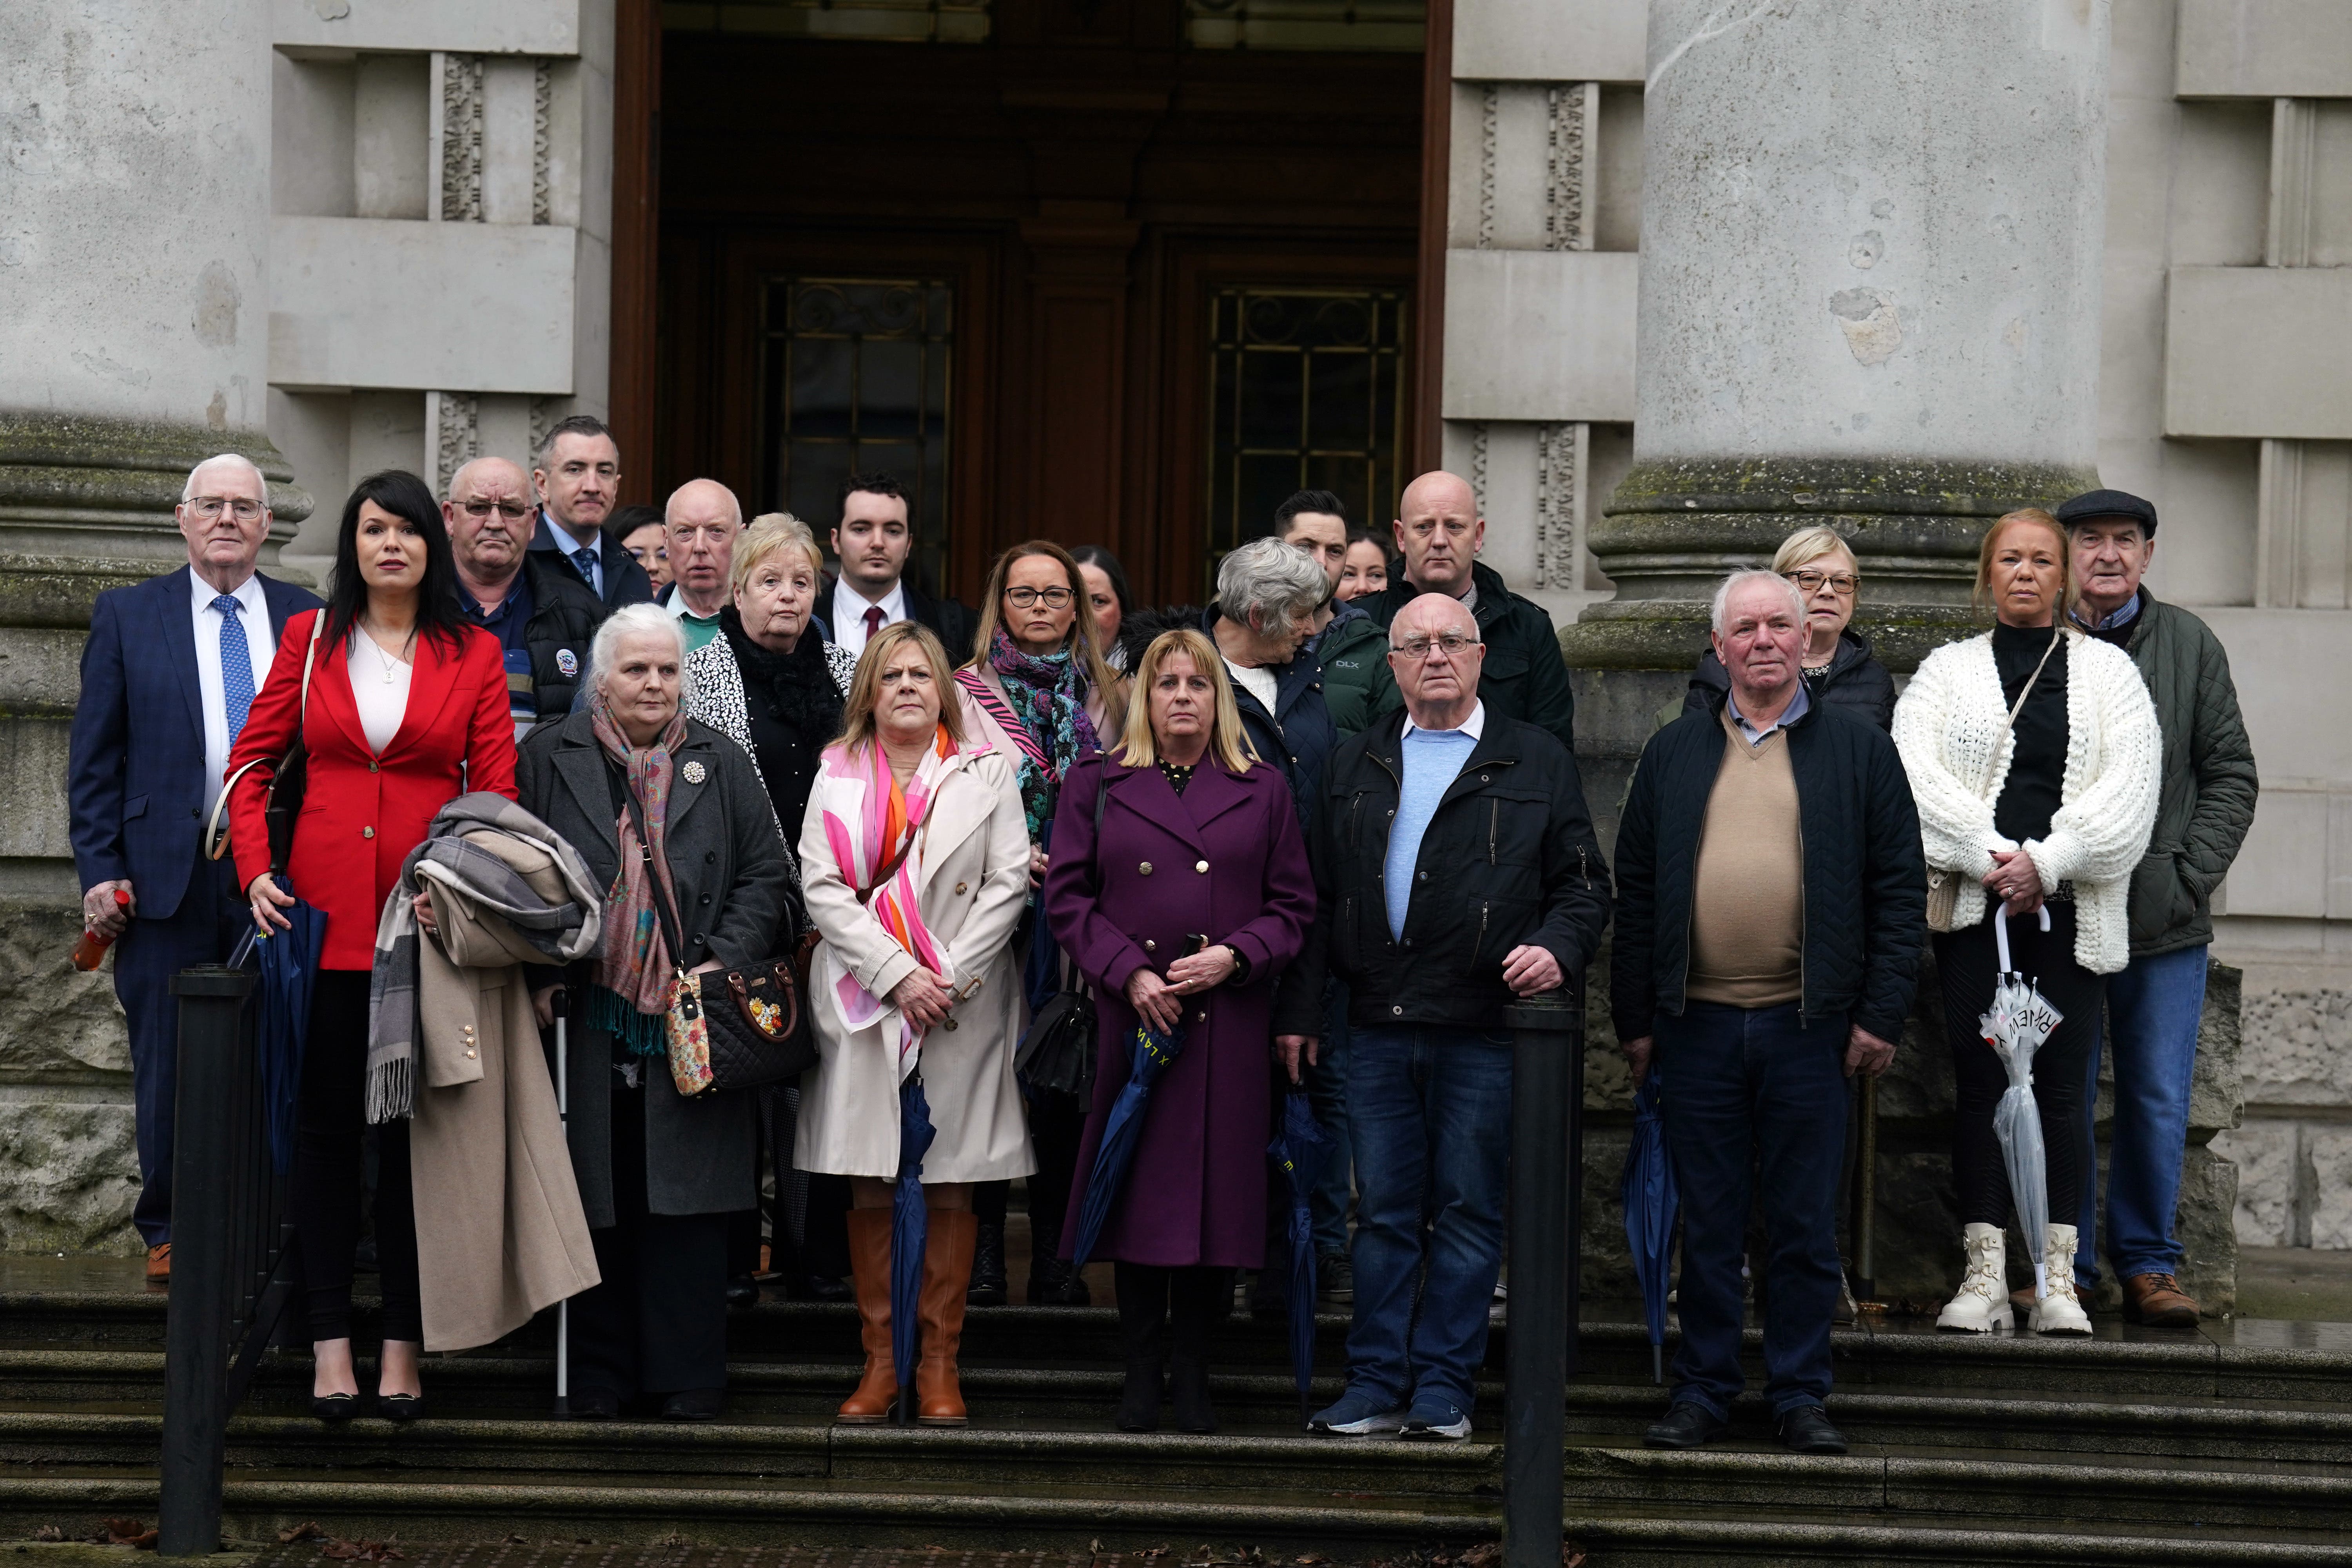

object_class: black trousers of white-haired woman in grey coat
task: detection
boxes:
[572,1079,731,1399]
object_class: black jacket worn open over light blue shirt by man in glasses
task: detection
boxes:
[1275,708,1609,1034]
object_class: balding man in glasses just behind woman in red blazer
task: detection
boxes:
[442,458,609,740]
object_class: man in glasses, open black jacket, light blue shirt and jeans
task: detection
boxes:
[1275,595,1609,1439]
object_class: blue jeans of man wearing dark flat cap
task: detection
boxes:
[2053,947,2206,1286]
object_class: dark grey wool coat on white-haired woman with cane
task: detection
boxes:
[515,710,797,1229]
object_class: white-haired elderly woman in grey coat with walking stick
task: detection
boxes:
[517,604,802,1420]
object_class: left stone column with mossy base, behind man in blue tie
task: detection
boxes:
[0,0,310,1253]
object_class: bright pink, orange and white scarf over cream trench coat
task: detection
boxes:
[811,724,969,1082]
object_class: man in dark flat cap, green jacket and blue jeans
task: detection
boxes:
[2058,489,2260,1328]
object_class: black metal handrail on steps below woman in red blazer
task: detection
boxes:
[155,964,294,1556]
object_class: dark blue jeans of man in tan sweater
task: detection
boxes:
[1656,1002,1846,1420]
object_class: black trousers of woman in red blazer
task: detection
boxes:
[289,969,426,1340]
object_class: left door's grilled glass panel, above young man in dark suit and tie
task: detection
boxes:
[760,278,955,590]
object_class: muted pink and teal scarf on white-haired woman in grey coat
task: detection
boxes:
[588,689,687,1056]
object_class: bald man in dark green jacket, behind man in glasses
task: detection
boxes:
[1317,472,1576,755]
